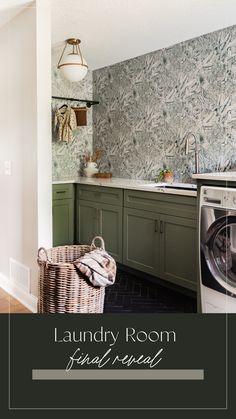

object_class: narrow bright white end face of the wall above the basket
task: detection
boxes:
[36,0,52,264]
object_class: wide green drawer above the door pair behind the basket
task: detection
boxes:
[77,185,123,206]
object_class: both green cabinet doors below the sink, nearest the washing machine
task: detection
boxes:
[123,208,197,290]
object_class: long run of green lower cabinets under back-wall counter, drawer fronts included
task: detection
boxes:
[75,185,197,290]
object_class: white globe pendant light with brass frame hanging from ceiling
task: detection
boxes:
[57,38,88,82]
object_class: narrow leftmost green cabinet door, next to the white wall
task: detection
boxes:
[53,199,74,246]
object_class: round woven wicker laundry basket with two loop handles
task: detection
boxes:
[38,237,105,313]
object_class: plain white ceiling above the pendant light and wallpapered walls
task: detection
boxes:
[0,0,236,69]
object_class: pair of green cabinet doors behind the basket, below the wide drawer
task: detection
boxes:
[76,200,122,262]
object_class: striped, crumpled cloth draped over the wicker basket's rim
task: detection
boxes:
[73,248,116,287]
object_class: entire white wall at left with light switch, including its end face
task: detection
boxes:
[0,0,52,302]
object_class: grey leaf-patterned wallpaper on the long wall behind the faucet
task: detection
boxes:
[93,26,236,181]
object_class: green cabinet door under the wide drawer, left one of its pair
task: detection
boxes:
[76,200,100,244]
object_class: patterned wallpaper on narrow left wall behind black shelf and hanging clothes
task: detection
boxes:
[52,50,93,180]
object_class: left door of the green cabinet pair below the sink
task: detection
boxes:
[123,208,160,275]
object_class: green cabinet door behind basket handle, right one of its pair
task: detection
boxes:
[99,204,122,263]
